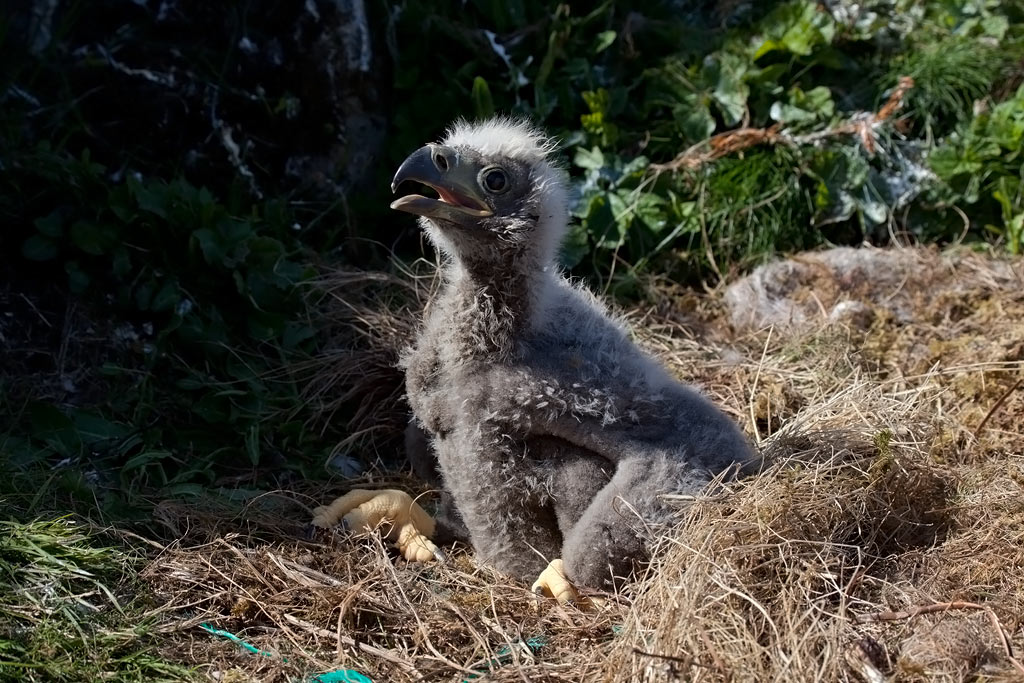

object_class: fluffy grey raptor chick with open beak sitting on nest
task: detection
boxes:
[313,117,756,602]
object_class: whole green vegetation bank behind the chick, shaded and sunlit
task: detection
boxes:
[0,0,1024,680]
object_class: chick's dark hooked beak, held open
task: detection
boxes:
[391,144,494,222]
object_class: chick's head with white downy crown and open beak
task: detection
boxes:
[391,118,568,266]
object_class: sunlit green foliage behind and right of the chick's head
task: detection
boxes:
[385,0,1024,279]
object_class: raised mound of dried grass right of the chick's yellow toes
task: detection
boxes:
[607,384,954,681]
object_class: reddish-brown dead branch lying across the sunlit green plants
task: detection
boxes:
[648,76,913,173]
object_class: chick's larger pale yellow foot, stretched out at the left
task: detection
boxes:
[310,488,444,562]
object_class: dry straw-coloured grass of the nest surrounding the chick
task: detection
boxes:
[144,248,1024,682]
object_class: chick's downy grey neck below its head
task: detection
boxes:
[442,249,553,361]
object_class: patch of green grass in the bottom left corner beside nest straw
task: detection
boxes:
[0,518,201,682]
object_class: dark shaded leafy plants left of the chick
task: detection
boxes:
[0,12,334,519]
